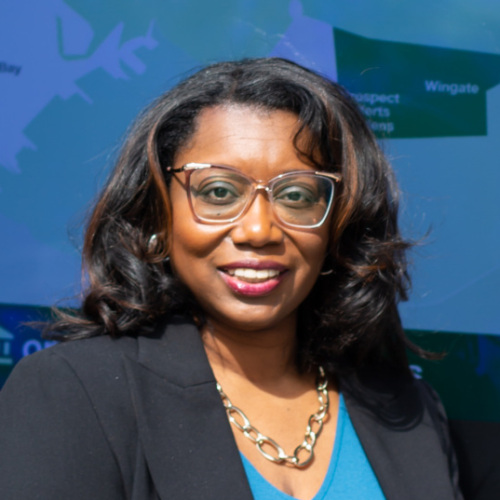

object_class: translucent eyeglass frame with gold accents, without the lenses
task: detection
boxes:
[165,162,342,229]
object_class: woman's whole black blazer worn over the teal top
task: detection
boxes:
[0,321,461,500]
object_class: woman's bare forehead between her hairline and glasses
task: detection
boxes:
[175,104,312,178]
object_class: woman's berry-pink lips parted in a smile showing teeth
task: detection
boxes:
[219,261,287,297]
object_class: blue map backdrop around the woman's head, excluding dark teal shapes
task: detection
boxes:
[0,0,500,339]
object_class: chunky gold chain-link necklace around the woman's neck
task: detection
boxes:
[217,366,330,468]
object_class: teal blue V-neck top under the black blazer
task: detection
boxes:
[240,395,385,500]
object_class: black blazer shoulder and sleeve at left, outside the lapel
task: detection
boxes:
[0,330,158,499]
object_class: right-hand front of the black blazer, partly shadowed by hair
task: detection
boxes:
[341,380,455,500]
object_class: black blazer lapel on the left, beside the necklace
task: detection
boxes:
[121,323,252,500]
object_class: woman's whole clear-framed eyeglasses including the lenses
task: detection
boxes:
[166,163,341,228]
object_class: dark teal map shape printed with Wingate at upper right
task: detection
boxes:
[334,29,500,138]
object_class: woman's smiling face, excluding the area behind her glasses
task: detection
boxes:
[170,105,330,330]
